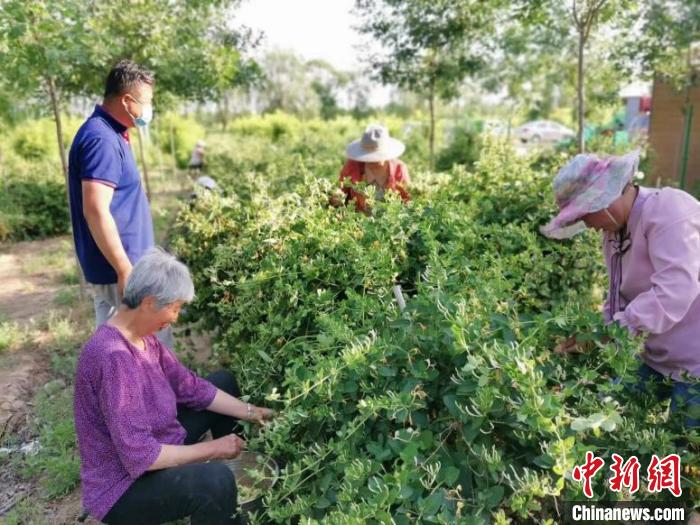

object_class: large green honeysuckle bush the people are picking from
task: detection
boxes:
[172,141,697,524]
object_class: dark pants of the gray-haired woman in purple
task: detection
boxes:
[104,370,244,525]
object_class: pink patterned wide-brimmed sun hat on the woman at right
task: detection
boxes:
[540,146,639,239]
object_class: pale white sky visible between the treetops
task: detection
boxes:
[233,0,390,105]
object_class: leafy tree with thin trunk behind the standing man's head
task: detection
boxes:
[0,0,258,290]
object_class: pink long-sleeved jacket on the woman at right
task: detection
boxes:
[603,187,700,380]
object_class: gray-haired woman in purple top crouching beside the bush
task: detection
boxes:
[74,249,272,524]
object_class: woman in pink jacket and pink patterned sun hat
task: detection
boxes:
[541,151,700,428]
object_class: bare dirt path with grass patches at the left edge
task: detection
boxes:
[0,236,94,524]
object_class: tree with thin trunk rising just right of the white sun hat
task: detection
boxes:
[355,0,508,165]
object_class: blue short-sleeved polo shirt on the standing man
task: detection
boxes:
[68,106,153,284]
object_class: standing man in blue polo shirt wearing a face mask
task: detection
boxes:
[68,60,173,346]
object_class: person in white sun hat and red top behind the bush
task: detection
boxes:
[340,124,410,212]
